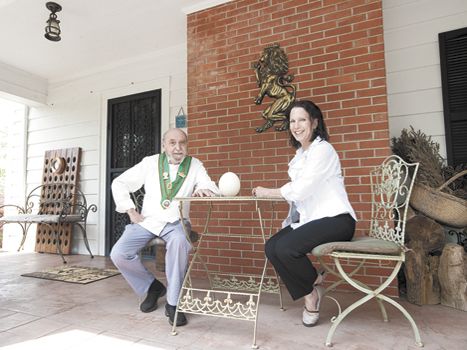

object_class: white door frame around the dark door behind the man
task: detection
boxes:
[97,76,170,255]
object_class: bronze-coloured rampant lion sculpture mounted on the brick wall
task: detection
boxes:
[253,44,296,132]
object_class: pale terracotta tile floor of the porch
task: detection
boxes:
[0,252,467,350]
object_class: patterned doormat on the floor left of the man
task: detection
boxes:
[21,266,120,284]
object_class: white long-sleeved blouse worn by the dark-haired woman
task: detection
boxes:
[280,137,357,229]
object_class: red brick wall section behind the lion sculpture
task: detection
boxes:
[187,0,395,293]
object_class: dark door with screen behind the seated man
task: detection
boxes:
[105,89,161,255]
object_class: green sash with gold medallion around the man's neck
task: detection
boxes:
[159,152,191,209]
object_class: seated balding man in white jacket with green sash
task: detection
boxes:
[110,129,219,326]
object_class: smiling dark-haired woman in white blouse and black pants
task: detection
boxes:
[253,100,356,327]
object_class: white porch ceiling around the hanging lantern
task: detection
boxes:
[0,0,225,83]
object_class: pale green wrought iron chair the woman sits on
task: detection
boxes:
[312,155,423,347]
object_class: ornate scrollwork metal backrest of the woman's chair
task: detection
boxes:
[370,155,419,247]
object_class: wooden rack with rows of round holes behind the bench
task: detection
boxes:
[35,147,81,254]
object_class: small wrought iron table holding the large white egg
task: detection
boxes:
[172,196,283,349]
